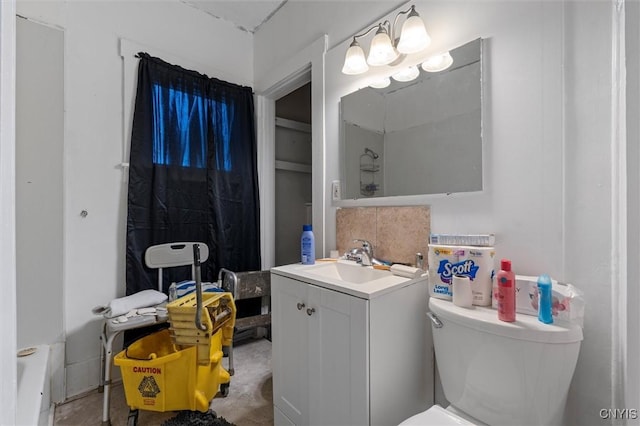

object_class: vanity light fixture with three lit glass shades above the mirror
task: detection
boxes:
[342,5,431,75]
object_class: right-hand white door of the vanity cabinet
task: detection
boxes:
[305,285,369,425]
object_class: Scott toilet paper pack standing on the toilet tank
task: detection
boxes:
[428,244,495,306]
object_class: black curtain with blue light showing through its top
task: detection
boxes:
[126,53,261,294]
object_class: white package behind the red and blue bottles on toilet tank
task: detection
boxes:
[491,275,584,327]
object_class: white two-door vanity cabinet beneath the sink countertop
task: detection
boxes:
[271,266,433,426]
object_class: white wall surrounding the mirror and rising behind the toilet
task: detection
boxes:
[254,0,620,424]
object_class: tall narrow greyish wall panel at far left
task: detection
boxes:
[16,18,65,402]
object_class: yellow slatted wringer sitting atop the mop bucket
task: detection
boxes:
[167,292,236,364]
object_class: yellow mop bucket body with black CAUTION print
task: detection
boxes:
[114,329,230,412]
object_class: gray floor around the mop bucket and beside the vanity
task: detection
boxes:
[54,339,273,426]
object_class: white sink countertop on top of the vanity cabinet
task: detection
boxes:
[271,260,427,299]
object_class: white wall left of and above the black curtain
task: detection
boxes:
[17,1,253,396]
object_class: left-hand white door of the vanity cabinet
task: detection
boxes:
[271,274,309,426]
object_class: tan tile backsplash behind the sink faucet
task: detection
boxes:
[336,206,431,267]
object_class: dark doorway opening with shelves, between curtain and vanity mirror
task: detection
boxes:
[275,82,313,266]
